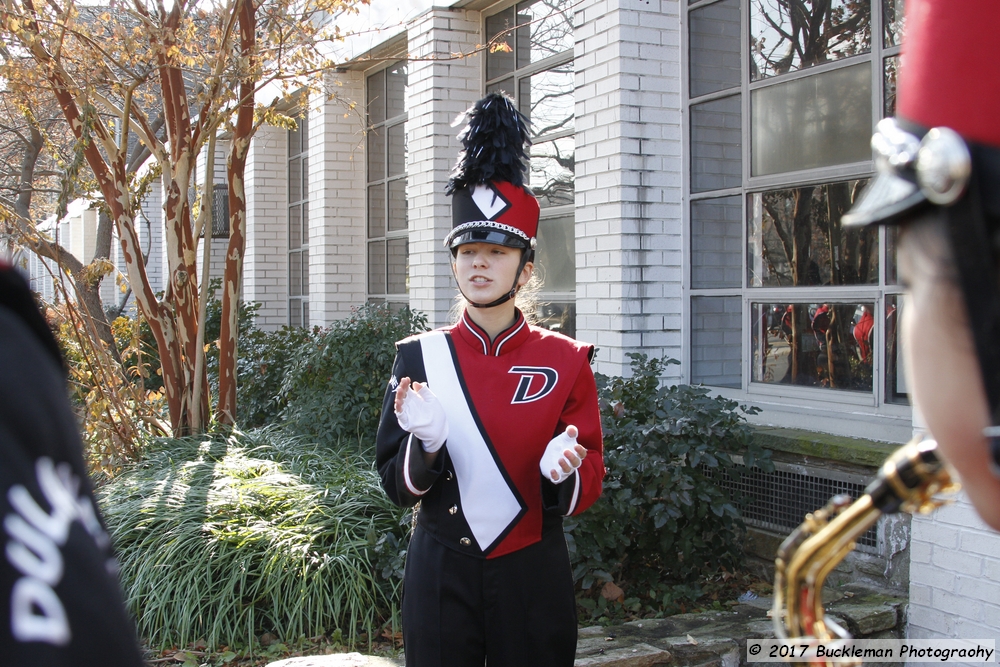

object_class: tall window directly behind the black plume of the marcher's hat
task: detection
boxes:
[485,0,576,336]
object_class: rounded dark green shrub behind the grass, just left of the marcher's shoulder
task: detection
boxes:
[282,305,427,454]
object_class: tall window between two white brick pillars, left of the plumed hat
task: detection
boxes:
[366,63,410,306]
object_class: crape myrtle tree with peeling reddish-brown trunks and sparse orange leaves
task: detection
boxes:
[0,0,366,435]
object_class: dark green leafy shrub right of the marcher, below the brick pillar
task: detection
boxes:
[565,354,773,616]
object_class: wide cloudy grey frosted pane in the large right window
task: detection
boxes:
[750,63,872,176]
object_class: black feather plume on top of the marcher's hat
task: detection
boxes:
[445,93,531,195]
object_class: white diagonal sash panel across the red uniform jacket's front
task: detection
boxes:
[420,331,522,551]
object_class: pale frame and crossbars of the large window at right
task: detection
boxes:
[680,0,911,418]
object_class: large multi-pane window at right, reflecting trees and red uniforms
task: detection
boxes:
[685,0,906,405]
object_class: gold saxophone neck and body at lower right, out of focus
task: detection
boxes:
[772,439,959,665]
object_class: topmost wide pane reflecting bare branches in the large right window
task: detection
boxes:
[750,0,871,81]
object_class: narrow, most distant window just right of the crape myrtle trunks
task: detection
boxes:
[288,111,309,327]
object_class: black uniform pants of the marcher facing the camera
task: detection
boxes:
[403,526,577,667]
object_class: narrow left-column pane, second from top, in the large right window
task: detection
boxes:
[691,95,743,192]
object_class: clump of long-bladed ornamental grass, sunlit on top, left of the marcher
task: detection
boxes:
[99,430,409,649]
